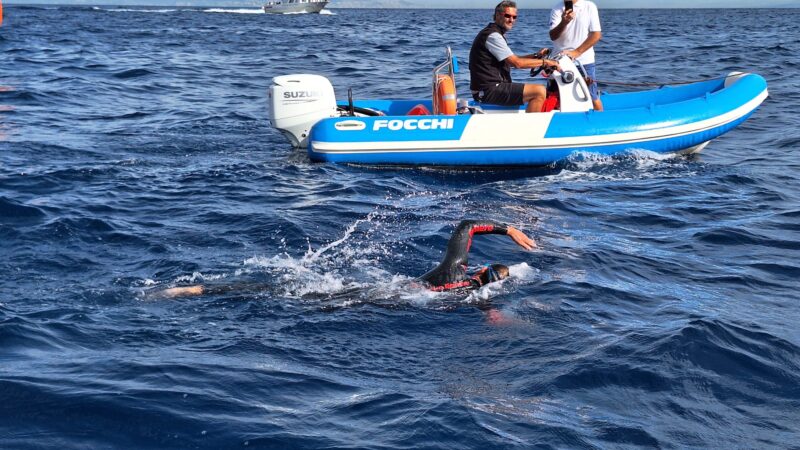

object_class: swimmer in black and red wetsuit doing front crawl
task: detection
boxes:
[156,220,536,298]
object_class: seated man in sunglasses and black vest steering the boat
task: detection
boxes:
[469,1,560,112]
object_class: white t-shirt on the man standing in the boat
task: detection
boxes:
[550,0,601,64]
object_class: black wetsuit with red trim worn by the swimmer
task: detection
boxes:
[419,220,508,291]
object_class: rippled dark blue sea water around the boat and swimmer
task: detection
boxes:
[0,4,800,449]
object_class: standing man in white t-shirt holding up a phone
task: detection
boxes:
[550,0,603,111]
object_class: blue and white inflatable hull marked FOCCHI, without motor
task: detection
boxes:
[308,74,767,166]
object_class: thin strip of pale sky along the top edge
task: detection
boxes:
[0,0,800,9]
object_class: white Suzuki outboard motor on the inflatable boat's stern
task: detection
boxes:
[269,74,338,147]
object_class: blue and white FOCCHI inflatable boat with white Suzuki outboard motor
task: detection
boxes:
[269,49,767,166]
